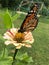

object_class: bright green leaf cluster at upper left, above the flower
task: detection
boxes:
[0,10,20,29]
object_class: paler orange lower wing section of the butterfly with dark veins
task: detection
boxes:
[23,18,38,31]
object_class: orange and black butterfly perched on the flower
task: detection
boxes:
[18,4,38,32]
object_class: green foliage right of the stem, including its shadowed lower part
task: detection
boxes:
[11,52,33,65]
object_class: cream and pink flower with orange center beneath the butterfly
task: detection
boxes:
[3,28,34,49]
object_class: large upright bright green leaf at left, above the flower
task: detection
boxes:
[3,11,12,29]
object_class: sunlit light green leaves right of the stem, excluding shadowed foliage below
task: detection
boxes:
[16,52,33,63]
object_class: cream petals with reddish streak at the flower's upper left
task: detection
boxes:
[3,28,18,40]
